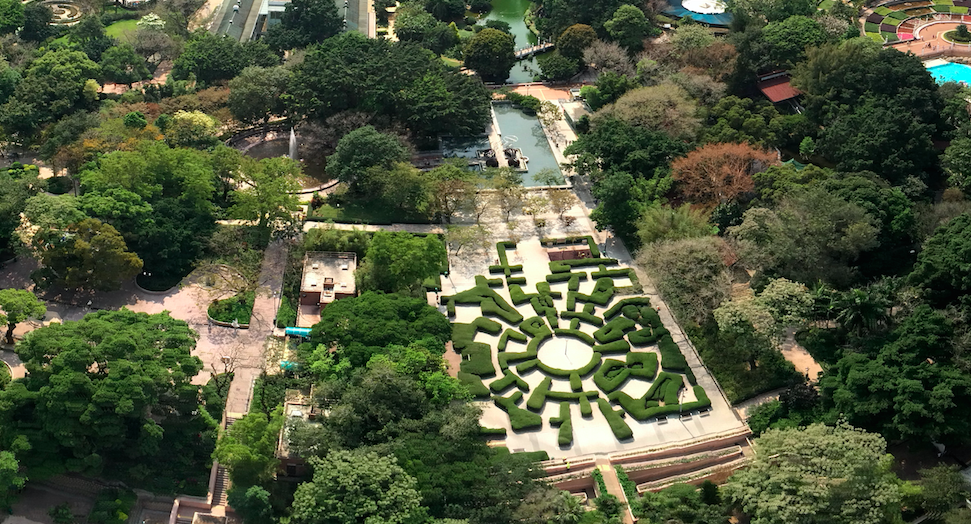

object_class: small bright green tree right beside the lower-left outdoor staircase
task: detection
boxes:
[212,408,283,491]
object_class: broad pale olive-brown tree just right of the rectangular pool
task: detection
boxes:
[592,84,701,141]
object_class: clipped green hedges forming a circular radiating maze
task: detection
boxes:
[442,237,711,448]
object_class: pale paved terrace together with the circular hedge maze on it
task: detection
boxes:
[441,237,741,456]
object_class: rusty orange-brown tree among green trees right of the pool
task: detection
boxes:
[671,144,779,207]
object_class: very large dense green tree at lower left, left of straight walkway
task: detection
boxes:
[0,309,207,478]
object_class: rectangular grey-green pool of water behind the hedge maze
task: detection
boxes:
[492,104,562,187]
